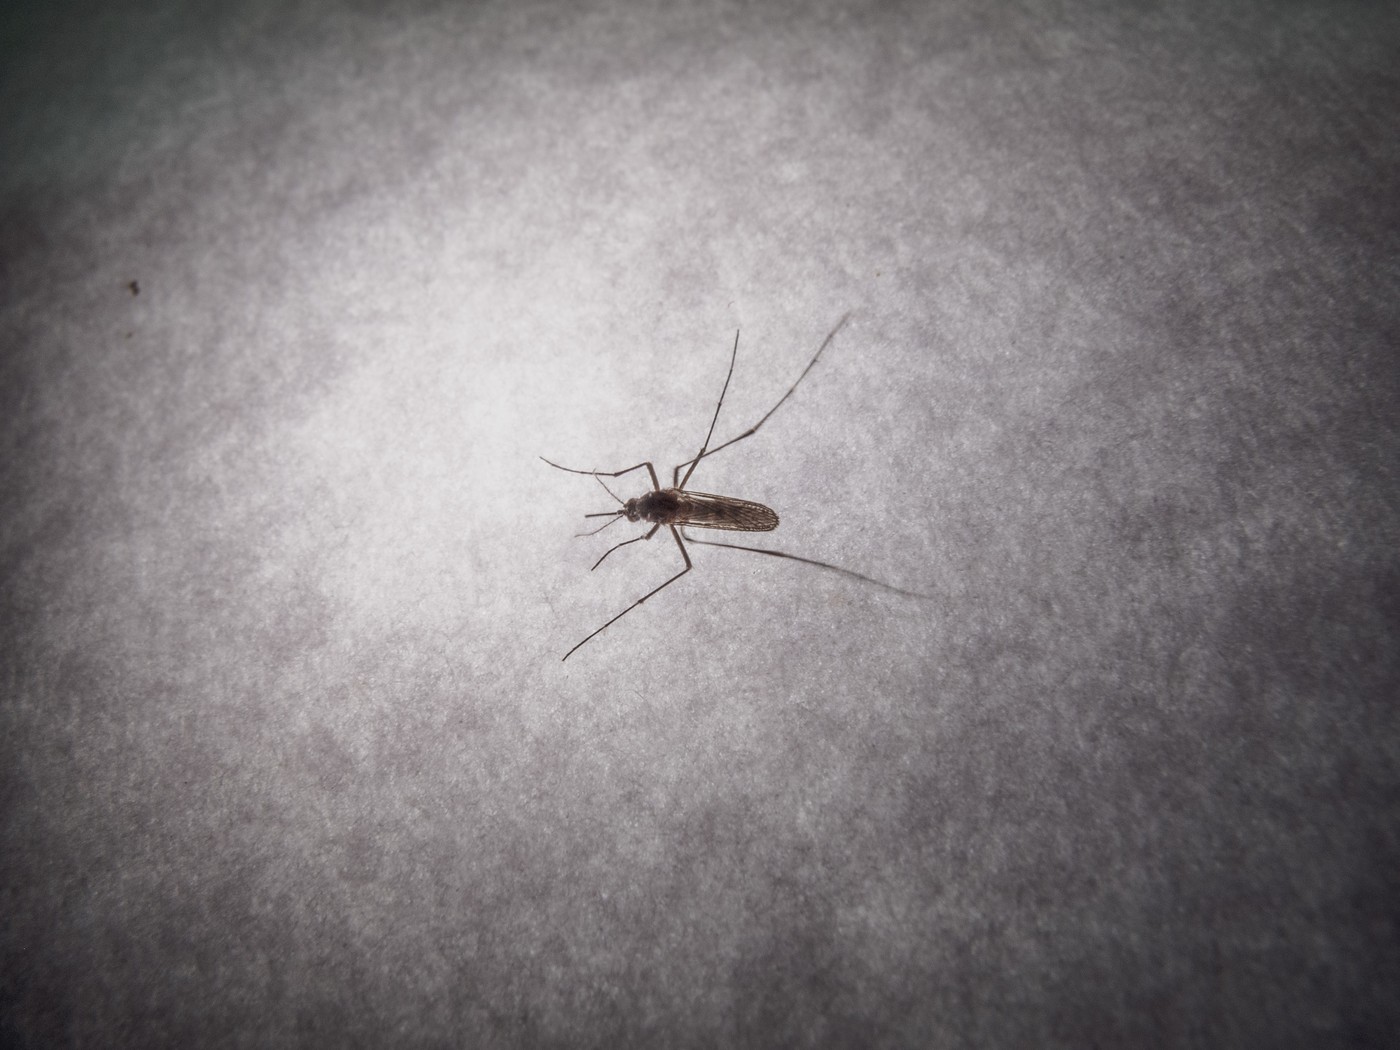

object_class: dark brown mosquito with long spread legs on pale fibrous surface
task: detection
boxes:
[540,314,930,659]
